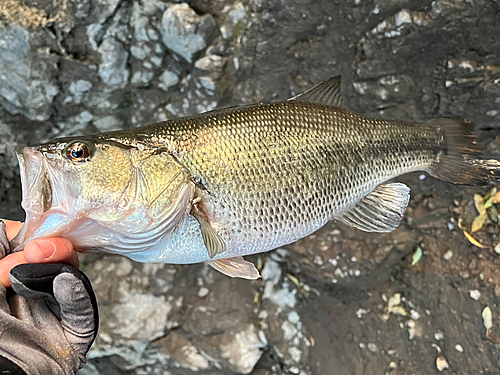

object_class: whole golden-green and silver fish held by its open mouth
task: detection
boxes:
[9,76,500,280]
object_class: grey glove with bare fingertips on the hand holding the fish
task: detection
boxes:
[0,221,99,375]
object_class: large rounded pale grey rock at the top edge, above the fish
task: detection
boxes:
[162,4,216,63]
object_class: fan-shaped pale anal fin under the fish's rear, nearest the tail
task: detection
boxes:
[337,183,410,233]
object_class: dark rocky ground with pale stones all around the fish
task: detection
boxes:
[0,0,500,375]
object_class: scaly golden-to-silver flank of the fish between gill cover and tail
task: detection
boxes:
[130,101,439,256]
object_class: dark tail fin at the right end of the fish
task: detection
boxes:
[429,119,500,185]
